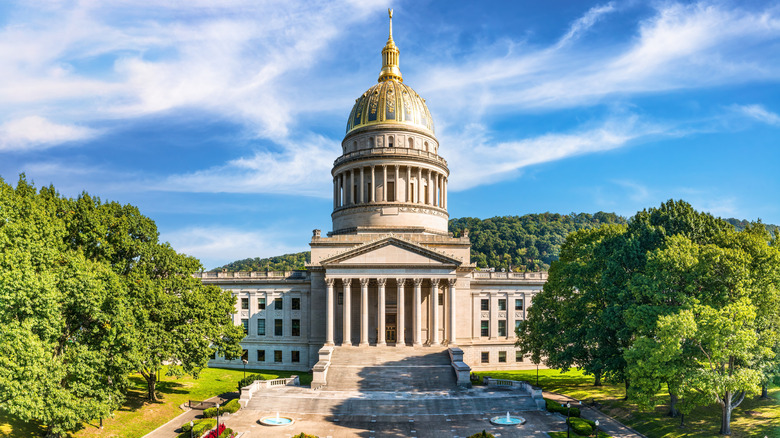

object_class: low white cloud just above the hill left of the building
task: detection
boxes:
[160,227,308,269]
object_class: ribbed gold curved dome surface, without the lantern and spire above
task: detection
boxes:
[347,79,434,134]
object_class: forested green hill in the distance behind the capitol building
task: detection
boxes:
[214,212,778,271]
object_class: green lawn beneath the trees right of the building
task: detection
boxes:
[477,369,780,438]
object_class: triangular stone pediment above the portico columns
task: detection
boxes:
[321,237,462,267]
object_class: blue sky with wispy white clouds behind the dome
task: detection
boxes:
[0,0,780,268]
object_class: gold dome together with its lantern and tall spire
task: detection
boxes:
[347,9,434,134]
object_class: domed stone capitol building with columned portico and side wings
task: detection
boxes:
[198,13,547,380]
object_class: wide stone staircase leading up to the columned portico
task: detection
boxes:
[322,346,456,392]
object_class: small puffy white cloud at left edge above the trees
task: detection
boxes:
[0,116,96,151]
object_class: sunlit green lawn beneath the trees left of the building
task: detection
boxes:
[0,368,312,438]
